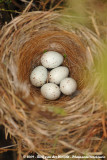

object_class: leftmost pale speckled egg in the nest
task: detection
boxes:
[30,66,48,87]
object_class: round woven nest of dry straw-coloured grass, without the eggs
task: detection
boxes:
[0,12,103,159]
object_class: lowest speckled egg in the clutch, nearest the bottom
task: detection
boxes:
[41,83,61,100]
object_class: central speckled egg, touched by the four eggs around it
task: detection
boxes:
[48,66,69,84]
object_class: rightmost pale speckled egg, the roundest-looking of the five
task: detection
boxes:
[60,77,77,95]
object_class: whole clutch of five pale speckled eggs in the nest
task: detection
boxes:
[30,51,77,100]
